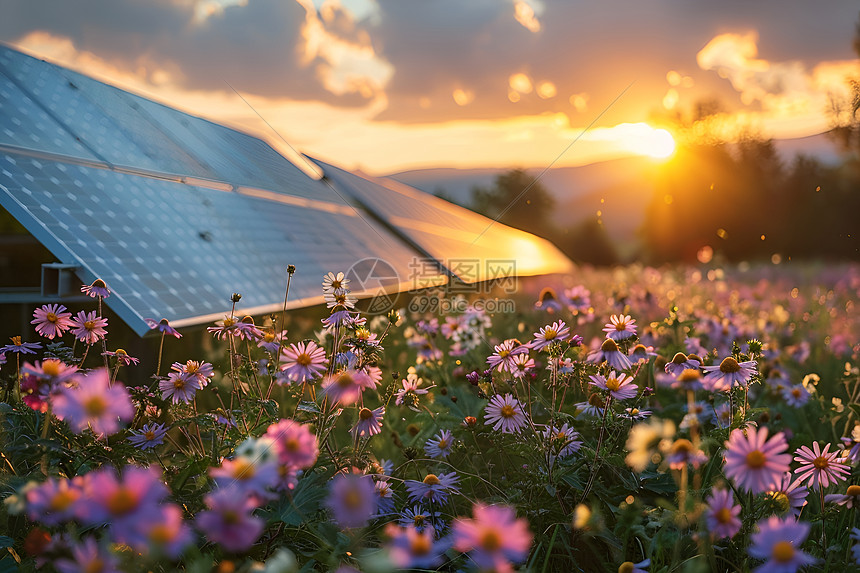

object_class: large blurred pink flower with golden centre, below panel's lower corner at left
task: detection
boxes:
[54,368,134,435]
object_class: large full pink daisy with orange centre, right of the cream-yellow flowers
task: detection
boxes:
[725,427,791,494]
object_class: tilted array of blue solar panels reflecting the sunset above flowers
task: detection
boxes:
[0,46,569,334]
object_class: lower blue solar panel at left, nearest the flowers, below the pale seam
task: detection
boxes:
[0,155,445,334]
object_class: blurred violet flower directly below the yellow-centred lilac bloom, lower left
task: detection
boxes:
[196,487,265,552]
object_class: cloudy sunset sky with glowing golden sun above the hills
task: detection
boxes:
[0,0,860,175]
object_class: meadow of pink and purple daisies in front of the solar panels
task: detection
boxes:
[0,264,860,573]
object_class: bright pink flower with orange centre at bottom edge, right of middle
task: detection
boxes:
[452,503,533,572]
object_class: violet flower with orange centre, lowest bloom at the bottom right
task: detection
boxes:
[749,515,817,573]
